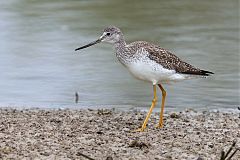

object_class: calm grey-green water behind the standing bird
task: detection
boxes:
[0,0,240,110]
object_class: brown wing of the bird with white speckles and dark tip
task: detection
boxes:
[143,44,213,76]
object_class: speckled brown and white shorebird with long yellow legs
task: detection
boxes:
[75,26,213,132]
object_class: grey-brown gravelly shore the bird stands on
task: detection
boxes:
[0,108,240,160]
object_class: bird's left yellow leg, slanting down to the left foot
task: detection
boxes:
[136,85,157,132]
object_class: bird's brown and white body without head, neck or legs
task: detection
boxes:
[114,41,212,84]
